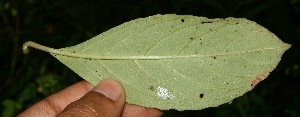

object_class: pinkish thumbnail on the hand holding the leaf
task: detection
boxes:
[93,79,123,101]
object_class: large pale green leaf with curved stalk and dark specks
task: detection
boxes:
[23,15,290,110]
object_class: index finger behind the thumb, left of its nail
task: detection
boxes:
[18,81,93,117]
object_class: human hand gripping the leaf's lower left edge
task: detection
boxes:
[18,79,163,117]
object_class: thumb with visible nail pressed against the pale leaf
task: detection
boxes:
[57,79,125,117]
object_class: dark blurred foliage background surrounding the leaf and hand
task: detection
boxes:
[0,0,300,117]
